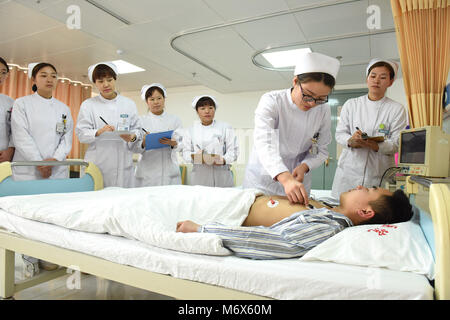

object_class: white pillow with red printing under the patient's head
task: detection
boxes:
[300,221,434,280]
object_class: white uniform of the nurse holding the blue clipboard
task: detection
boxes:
[134,112,182,187]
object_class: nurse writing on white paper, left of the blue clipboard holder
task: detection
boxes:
[75,62,141,188]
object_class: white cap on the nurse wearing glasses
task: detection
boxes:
[294,52,340,79]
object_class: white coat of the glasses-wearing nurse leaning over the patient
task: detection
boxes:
[243,89,331,196]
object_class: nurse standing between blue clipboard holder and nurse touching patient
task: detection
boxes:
[183,95,239,187]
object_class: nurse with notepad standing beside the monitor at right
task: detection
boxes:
[332,59,407,199]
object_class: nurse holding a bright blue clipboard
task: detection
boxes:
[135,83,182,187]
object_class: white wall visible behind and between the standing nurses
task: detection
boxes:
[119,78,412,185]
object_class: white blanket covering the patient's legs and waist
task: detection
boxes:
[0,185,260,255]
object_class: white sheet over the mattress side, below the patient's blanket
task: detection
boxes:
[0,210,433,299]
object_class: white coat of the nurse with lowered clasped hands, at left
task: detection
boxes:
[11,93,73,180]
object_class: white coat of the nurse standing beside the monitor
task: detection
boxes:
[332,95,407,199]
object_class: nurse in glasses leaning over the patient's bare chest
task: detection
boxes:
[243,52,339,204]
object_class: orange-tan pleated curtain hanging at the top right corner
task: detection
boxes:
[391,0,450,128]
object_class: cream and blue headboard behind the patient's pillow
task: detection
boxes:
[406,177,450,300]
